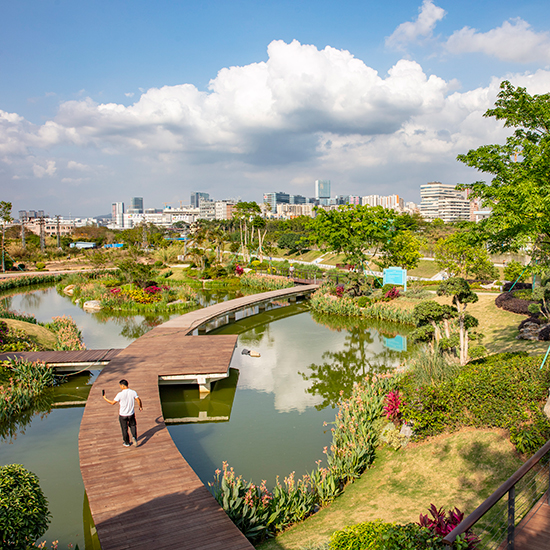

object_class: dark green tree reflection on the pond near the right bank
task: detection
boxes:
[300,312,416,410]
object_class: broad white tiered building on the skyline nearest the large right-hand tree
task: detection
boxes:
[420,181,470,223]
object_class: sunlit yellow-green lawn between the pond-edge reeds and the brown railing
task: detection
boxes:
[258,429,522,550]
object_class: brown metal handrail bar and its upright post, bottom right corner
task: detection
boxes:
[443,440,550,549]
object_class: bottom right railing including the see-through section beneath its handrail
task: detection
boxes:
[443,441,550,550]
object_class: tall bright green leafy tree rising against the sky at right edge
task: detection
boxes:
[457,81,550,264]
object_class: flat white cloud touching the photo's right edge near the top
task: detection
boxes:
[446,18,550,63]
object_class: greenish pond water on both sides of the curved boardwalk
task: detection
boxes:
[0,287,410,550]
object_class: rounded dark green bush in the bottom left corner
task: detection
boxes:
[0,464,51,550]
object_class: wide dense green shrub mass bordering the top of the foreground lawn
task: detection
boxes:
[401,353,550,452]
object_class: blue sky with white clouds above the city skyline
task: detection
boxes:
[0,0,550,217]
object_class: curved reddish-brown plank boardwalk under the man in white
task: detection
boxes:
[79,285,317,550]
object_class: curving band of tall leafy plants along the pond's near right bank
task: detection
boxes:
[209,375,396,542]
